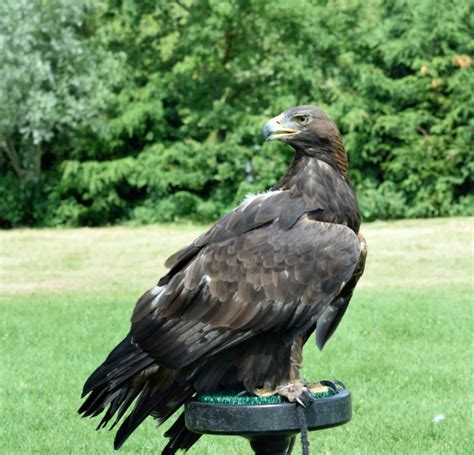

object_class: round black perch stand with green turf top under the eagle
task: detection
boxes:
[185,381,352,455]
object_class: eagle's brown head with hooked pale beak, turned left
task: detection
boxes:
[262,106,341,150]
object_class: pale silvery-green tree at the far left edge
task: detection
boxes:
[0,0,118,223]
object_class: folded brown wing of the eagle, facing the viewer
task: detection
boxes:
[131,212,361,369]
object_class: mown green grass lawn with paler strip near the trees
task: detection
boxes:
[0,218,474,455]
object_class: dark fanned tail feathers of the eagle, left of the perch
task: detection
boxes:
[79,336,195,449]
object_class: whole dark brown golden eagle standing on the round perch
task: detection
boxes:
[79,106,367,453]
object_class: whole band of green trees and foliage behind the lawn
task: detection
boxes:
[0,0,474,226]
